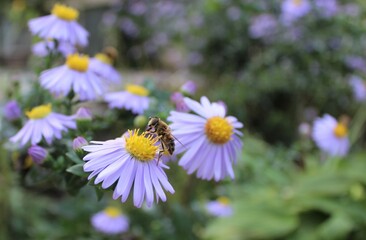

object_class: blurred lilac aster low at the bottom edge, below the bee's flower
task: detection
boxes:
[91,207,129,235]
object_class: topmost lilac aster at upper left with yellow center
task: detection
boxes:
[28,4,89,47]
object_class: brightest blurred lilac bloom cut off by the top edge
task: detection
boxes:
[281,0,311,25]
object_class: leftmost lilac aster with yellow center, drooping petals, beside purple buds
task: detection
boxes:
[10,104,76,146]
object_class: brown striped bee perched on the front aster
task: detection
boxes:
[146,117,176,163]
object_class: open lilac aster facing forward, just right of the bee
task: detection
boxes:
[168,97,243,181]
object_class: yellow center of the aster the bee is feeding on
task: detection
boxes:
[125,129,159,161]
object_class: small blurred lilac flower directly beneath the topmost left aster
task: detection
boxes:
[32,40,76,57]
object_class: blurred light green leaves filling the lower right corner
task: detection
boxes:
[205,150,366,239]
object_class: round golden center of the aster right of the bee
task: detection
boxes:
[205,117,233,144]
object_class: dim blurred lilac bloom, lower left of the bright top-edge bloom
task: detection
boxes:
[249,13,277,38]
